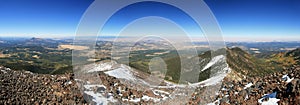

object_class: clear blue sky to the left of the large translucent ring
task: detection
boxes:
[0,0,93,37]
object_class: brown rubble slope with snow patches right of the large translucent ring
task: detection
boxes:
[206,66,300,105]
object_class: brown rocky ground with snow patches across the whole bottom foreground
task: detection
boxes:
[0,64,300,105]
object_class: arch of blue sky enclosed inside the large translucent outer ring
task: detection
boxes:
[102,2,202,36]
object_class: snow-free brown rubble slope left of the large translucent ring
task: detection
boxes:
[0,67,86,105]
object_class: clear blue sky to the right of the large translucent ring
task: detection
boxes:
[205,0,300,40]
